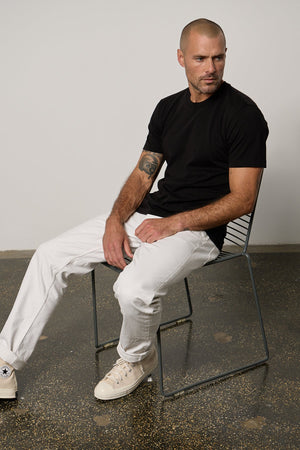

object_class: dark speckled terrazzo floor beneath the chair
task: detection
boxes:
[0,253,300,450]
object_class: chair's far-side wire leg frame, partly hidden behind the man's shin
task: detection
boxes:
[91,270,193,351]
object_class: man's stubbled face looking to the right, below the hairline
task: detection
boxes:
[177,30,226,102]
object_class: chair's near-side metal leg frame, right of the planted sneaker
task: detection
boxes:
[157,254,269,397]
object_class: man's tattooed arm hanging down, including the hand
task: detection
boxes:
[103,150,163,269]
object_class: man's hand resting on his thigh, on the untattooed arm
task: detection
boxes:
[135,215,181,244]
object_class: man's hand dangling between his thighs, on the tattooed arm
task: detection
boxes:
[103,217,133,270]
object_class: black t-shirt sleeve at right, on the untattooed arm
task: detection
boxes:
[228,105,269,167]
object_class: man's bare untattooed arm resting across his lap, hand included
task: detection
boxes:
[136,167,262,243]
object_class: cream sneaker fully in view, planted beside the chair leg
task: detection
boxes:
[94,348,157,400]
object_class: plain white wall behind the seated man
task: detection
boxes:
[0,0,300,250]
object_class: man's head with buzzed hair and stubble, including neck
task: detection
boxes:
[177,19,226,102]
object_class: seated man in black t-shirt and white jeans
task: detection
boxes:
[0,19,268,400]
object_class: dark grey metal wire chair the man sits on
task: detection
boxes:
[92,187,269,397]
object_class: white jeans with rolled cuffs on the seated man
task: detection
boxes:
[0,213,219,369]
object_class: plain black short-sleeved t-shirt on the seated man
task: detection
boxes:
[137,82,268,248]
